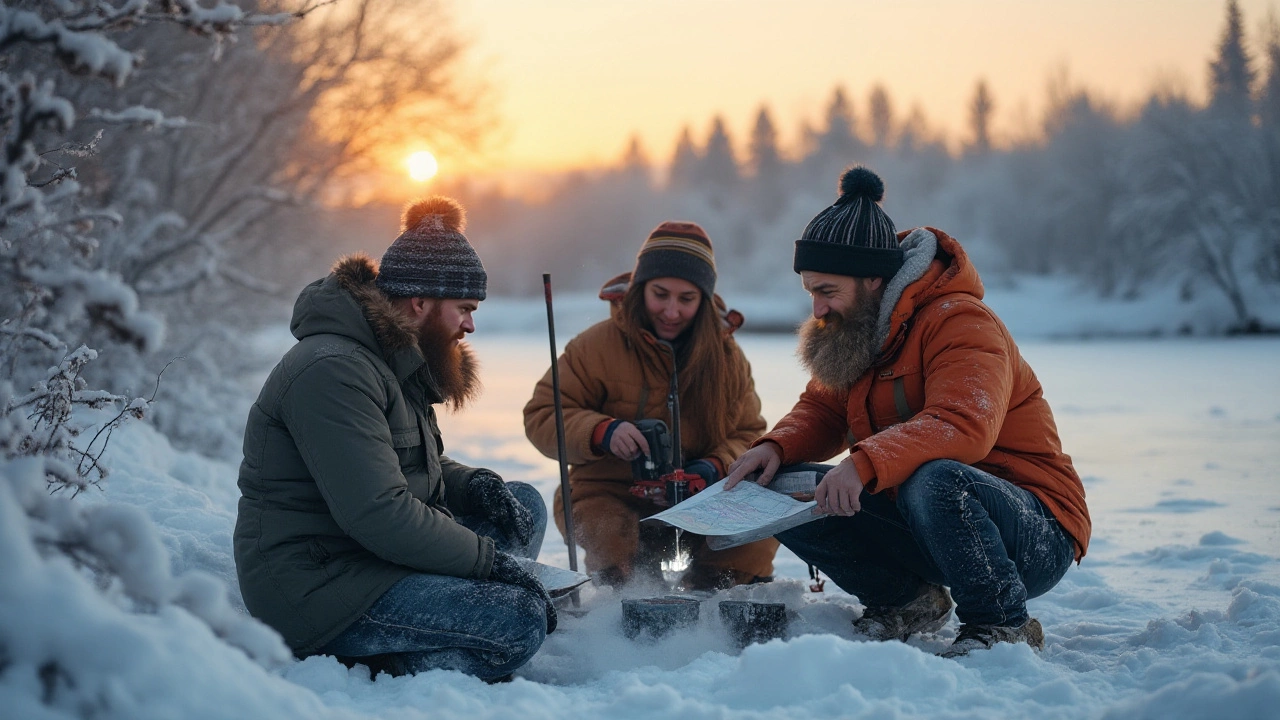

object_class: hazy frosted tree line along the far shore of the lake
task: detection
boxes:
[451,0,1280,332]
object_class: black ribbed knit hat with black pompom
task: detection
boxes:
[792,165,902,278]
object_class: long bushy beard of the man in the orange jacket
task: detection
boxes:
[796,285,881,391]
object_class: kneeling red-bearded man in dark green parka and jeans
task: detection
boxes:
[234,197,556,680]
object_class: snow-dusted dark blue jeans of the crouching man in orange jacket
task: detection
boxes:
[777,460,1075,626]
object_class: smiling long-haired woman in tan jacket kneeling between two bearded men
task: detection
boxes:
[525,222,778,589]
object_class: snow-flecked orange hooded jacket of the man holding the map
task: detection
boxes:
[756,228,1092,560]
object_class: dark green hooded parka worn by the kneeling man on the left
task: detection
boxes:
[234,256,494,655]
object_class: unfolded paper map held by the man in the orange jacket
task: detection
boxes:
[646,465,826,550]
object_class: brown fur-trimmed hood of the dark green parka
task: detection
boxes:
[289,254,425,380]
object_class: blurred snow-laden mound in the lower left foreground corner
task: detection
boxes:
[0,450,299,717]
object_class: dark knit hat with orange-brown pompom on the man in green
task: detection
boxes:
[375,195,489,300]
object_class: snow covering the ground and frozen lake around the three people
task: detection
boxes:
[0,316,1280,719]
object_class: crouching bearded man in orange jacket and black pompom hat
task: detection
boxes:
[726,167,1091,657]
